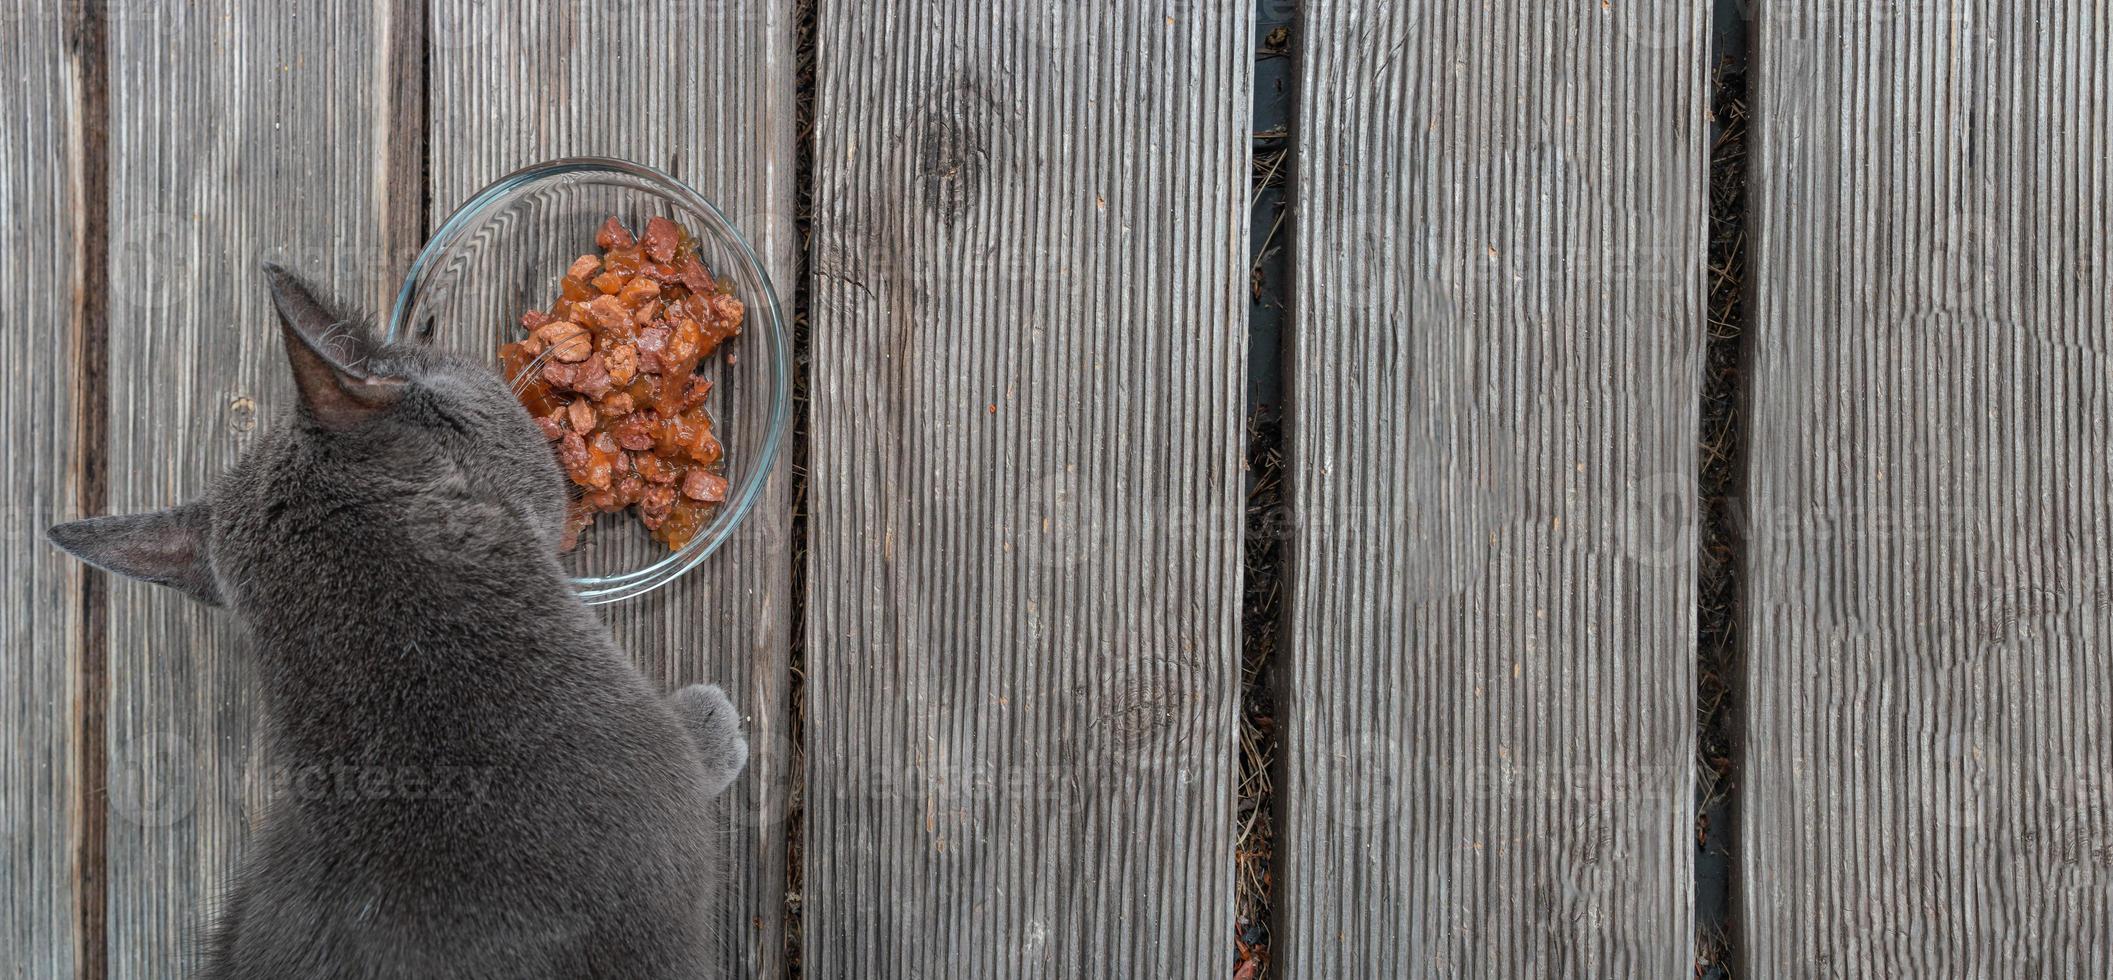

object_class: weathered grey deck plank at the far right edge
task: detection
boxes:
[1745,0,2113,978]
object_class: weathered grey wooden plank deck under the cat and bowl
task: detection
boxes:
[0,0,2113,980]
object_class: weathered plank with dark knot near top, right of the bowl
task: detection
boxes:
[803,0,1253,978]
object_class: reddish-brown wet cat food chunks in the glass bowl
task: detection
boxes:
[499,218,744,551]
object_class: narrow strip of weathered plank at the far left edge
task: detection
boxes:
[0,0,87,980]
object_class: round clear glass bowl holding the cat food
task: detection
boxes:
[387,156,792,602]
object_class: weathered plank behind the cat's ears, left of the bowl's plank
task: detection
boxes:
[106,0,418,978]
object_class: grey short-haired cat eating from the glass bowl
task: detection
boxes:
[51,266,748,980]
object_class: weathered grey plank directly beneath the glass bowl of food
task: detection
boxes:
[429,0,799,976]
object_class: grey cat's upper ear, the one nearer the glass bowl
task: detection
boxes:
[264,262,404,431]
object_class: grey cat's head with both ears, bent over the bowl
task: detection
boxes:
[51,264,568,608]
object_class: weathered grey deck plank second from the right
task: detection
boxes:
[1276,0,1705,980]
